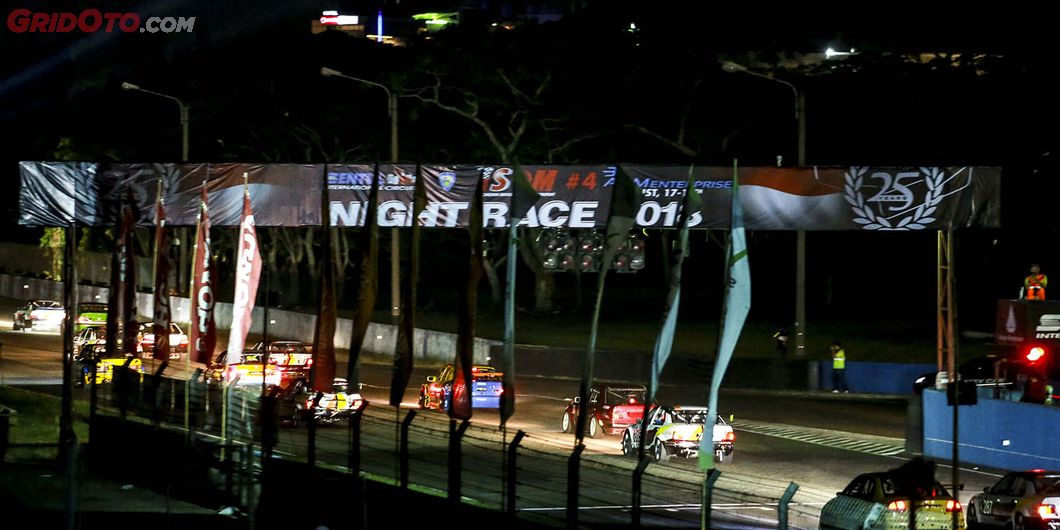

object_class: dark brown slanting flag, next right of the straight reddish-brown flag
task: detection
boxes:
[345,164,381,390]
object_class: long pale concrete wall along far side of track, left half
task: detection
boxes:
[0,275,496,364]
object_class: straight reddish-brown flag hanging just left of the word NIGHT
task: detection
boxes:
[311,172,337,389]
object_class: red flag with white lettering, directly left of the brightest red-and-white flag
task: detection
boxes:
[189,186,217,364]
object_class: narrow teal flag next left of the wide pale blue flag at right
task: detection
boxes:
[641,165,703,400]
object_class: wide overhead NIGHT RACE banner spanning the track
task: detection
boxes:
[19,161,1001,230]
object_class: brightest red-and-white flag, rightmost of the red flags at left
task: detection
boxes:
[228,183,262,363]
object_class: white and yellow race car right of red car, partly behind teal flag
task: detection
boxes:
[622,405,736,462]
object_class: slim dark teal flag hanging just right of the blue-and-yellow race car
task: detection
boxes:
[500,160,541,425]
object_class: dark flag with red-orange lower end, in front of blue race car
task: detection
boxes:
[449,167,485,420]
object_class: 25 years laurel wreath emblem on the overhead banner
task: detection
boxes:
[843,167,972,230]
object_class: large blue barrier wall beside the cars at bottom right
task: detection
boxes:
[923,389,1060,470]
